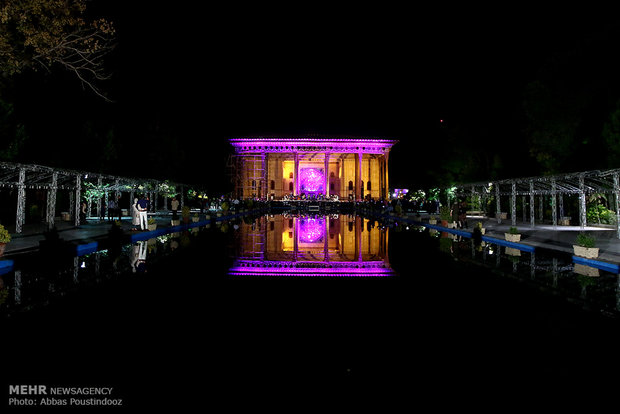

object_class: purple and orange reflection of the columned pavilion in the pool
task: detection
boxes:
[229,215,394,276]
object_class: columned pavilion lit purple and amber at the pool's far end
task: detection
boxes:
[230,137,398,201]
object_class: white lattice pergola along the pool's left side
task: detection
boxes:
[0,162,202,233]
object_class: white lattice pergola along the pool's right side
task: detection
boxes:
[448,169,620,238]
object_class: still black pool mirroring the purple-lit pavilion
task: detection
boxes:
[2,215,620,401]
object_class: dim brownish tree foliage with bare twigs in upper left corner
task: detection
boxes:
[0,0,115,100]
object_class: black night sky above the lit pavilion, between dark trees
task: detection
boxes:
[8,0,611,192]
